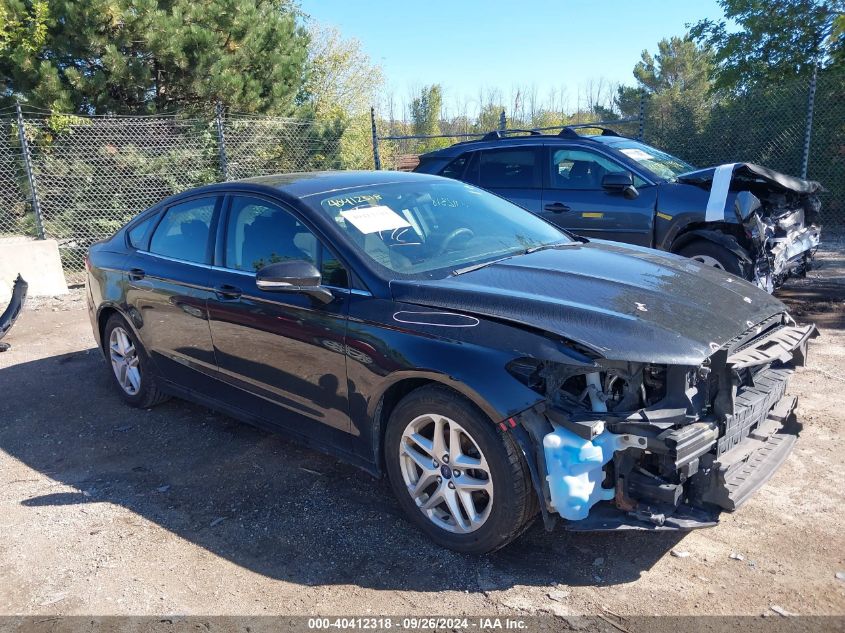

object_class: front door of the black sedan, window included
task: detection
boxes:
[208,195,349,433]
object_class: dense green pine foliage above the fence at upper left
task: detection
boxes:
[0,0,308,114]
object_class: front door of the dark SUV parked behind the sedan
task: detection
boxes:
[541,145,657,246]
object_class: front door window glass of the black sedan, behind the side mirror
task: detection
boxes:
[225,196,348,288]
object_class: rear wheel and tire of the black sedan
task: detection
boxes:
[103,314,170,409]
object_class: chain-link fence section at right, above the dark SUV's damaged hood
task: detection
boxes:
[643,68,845,225]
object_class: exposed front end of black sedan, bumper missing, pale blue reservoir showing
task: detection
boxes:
[511,313,818,530]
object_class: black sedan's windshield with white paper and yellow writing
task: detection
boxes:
[304,181,572,278]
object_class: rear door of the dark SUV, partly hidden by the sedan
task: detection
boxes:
[464,145,543,213]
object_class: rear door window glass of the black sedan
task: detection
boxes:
[150,197,217,264]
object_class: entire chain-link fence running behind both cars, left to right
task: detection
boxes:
[0,69,845,284]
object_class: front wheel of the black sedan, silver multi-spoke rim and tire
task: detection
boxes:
[384,385,537,554]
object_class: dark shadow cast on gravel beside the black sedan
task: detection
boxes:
[0,348,683,592]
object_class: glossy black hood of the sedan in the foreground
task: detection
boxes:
[391,241,785,365]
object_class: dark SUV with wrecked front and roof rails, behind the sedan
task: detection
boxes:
[415,125,821,292]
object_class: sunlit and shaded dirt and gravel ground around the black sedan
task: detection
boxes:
[0,240,845,622]
